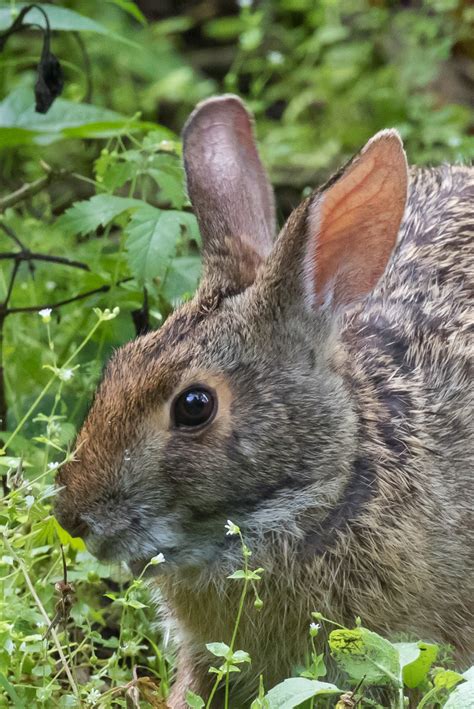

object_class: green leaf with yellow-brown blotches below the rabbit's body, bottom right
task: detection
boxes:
[329,628,400,685]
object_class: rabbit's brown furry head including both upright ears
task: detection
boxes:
[57,96,407,569]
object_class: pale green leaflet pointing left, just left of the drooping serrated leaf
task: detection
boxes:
[56,194,145,235]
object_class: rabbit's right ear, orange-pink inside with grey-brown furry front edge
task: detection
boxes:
[267,130,408,309]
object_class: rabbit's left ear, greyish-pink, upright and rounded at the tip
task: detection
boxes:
[183,95,275,290]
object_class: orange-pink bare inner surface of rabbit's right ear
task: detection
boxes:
[309,131,408,306]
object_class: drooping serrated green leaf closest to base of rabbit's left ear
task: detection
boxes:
[125,206,195,286]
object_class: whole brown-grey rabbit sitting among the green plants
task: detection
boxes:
[56,95,474,709]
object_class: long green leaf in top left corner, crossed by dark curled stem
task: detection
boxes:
[0,2,134,44]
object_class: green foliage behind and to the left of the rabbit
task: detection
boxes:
[0,0,474,706]
